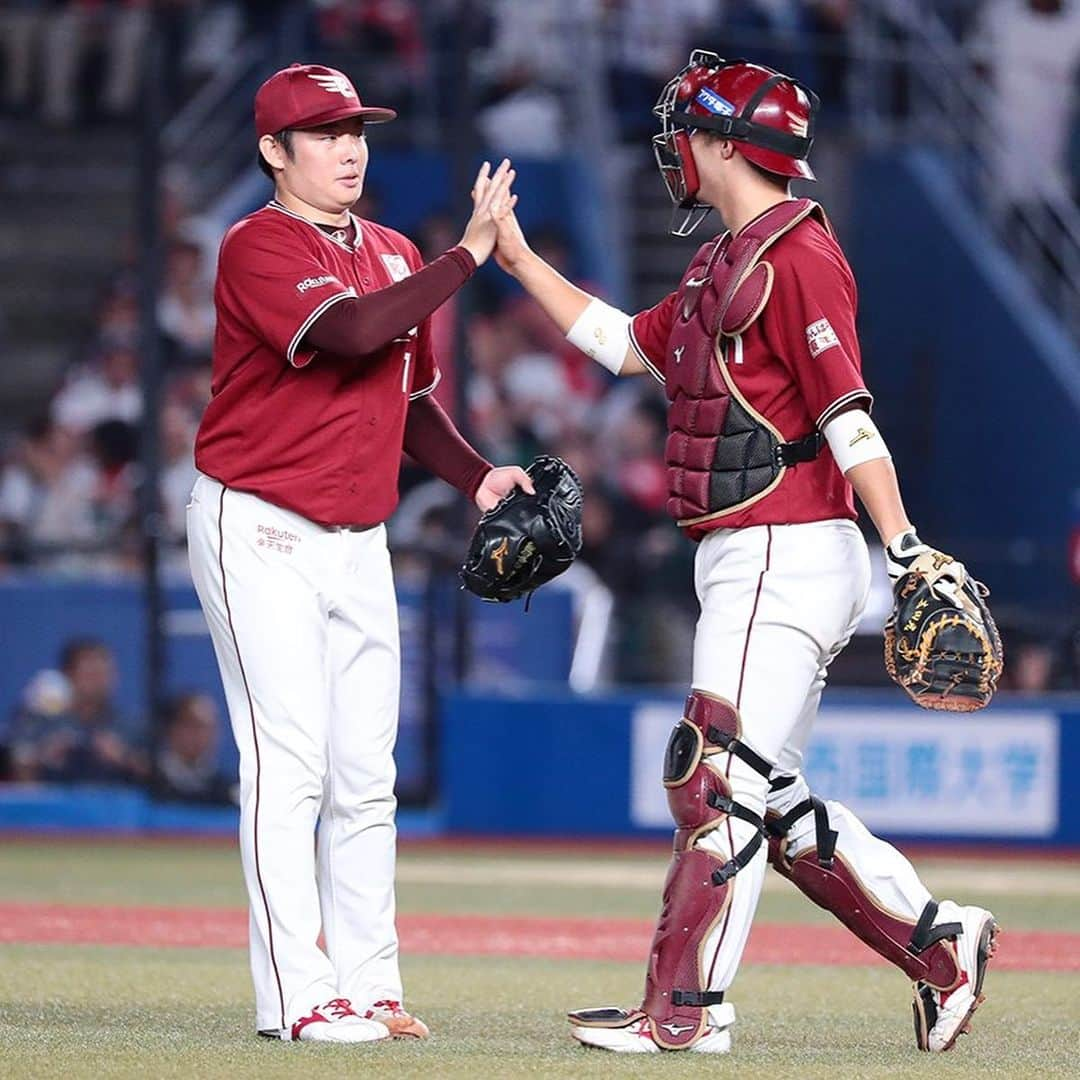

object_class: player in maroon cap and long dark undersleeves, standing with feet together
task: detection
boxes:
[188,64,531,1042]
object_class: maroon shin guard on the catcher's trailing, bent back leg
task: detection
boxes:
[769,822,960,990]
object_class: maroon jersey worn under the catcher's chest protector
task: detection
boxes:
[630,218,872,538]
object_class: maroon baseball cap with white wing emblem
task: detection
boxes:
[255,64,397,138]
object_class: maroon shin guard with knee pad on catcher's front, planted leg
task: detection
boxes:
[642,691,770,1050]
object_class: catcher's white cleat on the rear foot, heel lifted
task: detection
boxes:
[912,900,998,1053]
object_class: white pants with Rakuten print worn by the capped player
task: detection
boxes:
[188,476,402,1030]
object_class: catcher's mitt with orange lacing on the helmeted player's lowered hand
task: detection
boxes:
[885,530,1002,713]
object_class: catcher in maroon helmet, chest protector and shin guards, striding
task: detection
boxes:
[497,51,996,1053]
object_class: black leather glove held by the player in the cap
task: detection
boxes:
[460,455,582,604]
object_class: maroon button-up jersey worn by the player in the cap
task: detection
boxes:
[195,202,438,525]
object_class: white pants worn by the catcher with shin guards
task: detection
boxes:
[693,521,930,990]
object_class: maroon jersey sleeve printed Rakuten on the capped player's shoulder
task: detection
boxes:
[218,225,356,367]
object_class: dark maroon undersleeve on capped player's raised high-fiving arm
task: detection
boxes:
[302,247,476,356]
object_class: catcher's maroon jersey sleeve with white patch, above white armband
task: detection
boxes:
[761,243,873,431]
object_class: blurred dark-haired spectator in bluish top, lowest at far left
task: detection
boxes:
[10,638,148,784]
